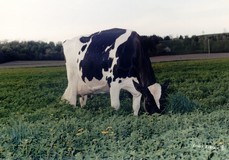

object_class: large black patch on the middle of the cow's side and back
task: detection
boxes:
[80,29,126,83]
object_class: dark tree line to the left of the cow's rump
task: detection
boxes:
[0,41,64,63]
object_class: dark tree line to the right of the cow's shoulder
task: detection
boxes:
[141,33,229,57]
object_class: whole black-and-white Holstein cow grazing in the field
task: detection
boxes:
[62,28,167,115]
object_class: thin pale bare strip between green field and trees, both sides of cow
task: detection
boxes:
[0,53,229,68]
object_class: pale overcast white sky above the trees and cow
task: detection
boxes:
[0,0,229,42]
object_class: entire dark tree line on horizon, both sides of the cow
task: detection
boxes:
[0,33,229,63]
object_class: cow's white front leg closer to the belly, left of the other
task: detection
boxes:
[110,83,120,110]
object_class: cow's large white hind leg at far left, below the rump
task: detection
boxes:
[61,64,77,106]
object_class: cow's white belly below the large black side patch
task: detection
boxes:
[77,78,109,96]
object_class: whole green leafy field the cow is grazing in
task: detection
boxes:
[0,59,229,160]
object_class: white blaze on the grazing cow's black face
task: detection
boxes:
[148,83,161,109]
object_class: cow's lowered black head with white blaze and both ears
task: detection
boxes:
[133,81,169,114]
